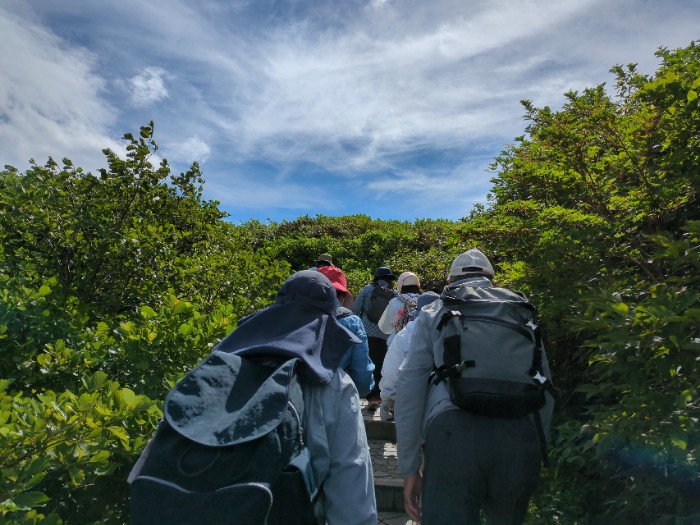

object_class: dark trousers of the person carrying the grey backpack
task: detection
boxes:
[421,410,542,525]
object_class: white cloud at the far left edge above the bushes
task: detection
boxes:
[0,7,120,170]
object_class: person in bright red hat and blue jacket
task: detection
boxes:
[316,266,374,396]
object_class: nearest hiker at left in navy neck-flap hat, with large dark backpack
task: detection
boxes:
[128,270,377,525]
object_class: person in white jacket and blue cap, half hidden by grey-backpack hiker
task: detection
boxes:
[379,291,439,421]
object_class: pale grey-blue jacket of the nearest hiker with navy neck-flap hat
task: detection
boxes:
[304,369,377,525]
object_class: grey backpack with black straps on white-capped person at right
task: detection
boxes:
[431,287,554,464]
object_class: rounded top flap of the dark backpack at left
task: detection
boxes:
[163,351,298,447]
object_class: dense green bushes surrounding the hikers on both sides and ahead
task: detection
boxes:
[0,44,700,524]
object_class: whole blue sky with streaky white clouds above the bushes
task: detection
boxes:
[0,0,700,222]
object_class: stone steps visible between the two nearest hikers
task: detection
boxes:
[362,400,403,512]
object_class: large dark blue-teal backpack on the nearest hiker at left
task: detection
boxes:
[129,350,317,525]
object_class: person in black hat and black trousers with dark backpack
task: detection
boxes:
[352,266,396,412]
